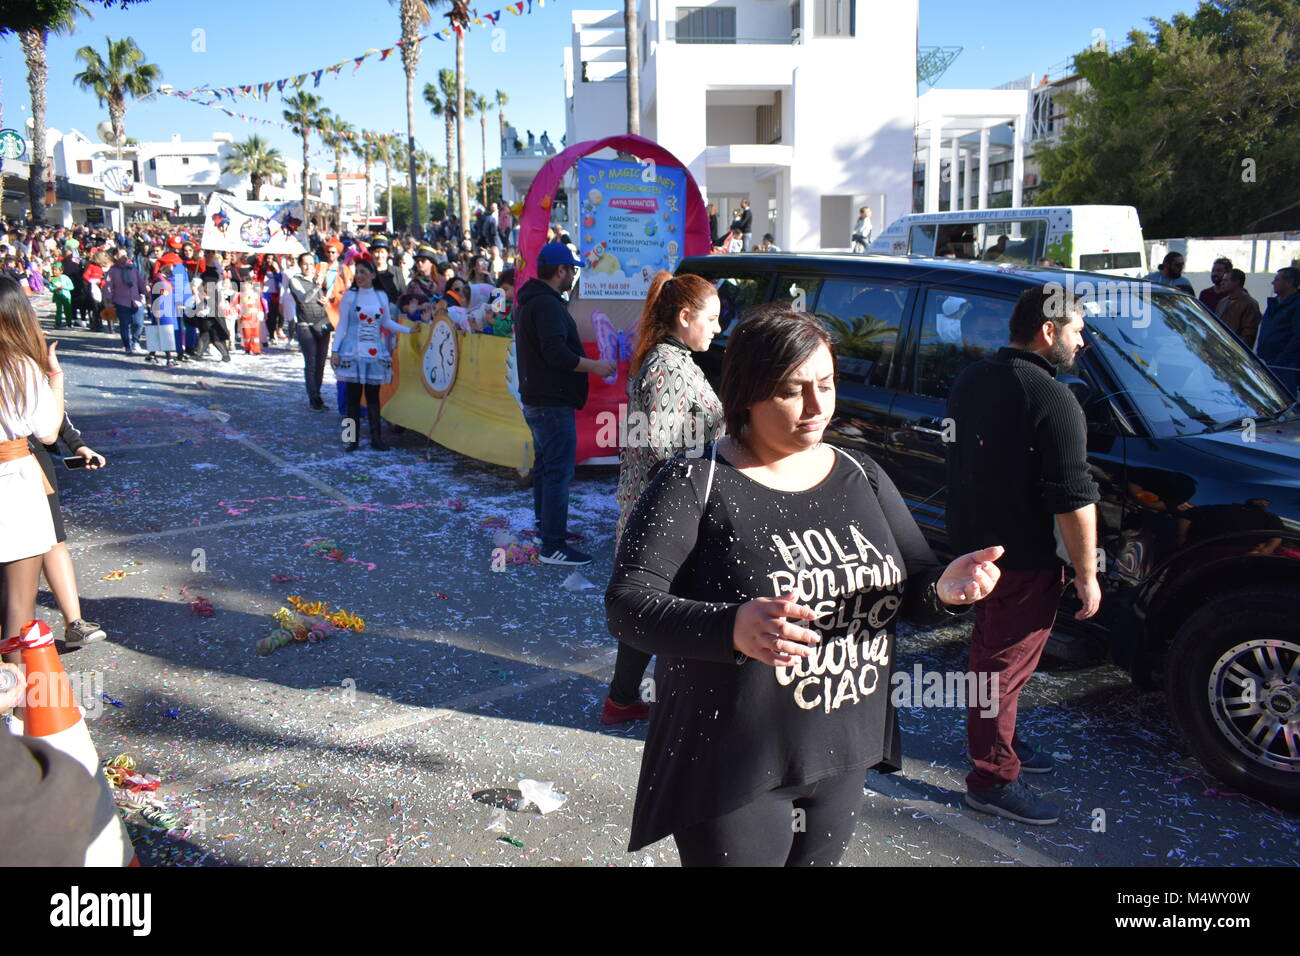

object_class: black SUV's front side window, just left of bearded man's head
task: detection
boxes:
[915,289,1015,398]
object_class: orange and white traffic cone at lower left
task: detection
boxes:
[17,620,139,866]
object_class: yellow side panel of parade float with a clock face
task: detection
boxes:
[380,311,533,470]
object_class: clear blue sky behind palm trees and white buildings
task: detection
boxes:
[0,0,1196,178]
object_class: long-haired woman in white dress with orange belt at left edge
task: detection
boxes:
[0,278,64,663]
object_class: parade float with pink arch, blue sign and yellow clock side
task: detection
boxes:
[380,135,712,468]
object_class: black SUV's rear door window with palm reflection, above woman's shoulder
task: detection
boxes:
[816,278,911,388]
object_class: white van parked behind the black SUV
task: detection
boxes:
[868,206,1147,278]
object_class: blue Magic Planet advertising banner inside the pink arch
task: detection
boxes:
[577,159,686,299]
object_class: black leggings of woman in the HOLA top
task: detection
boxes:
[672,769,866,866]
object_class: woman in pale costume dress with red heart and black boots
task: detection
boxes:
[330,258,412,451]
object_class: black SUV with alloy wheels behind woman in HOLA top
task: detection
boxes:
[677,254,1300,809]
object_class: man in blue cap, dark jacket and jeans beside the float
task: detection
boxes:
[515,242,615,566]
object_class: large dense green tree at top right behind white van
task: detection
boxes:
[1035,0,1300,237]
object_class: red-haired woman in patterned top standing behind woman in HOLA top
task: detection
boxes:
[601,272,725,723]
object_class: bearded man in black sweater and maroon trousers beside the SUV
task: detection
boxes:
[948,285,1101,823]
